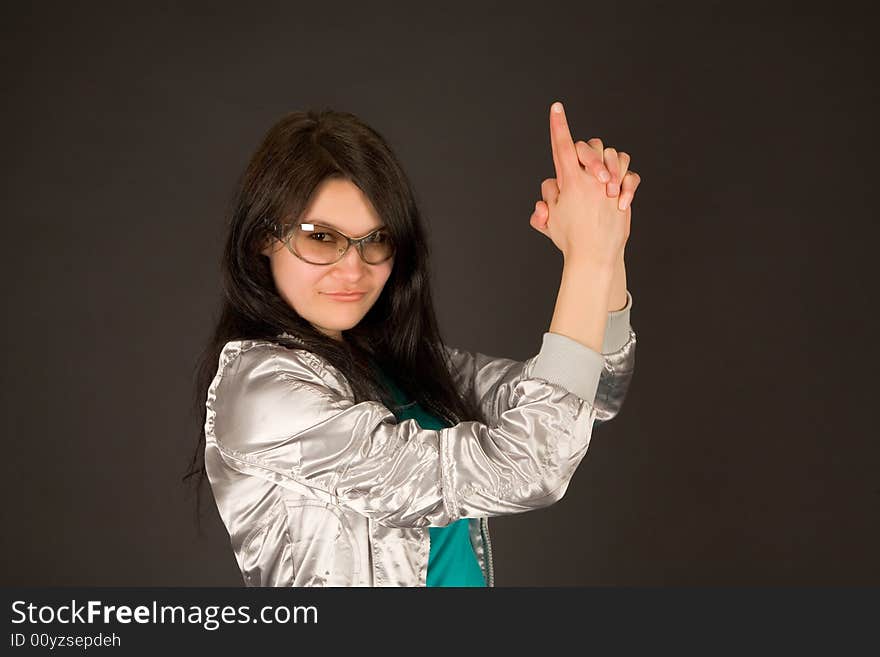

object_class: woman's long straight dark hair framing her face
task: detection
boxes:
[183,109,485,524]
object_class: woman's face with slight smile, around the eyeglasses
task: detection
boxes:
[263,178,394,340]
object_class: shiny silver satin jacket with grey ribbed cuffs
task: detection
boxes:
[205,292,636,586]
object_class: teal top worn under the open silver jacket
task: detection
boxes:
[368,364,486,586]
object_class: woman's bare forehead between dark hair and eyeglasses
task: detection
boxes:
[300,178,383,236]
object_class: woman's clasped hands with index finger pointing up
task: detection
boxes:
[530,103,641,266]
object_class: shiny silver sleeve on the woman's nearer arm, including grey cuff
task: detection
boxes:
[205,333,603,527]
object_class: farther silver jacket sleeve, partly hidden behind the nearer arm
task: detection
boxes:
[446,290,636,424]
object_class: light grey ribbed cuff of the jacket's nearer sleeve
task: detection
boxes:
[531,332,605,404]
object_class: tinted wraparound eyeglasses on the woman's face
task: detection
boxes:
[271,223,394,265]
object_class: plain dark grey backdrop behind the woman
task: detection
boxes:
[0,2,880,586]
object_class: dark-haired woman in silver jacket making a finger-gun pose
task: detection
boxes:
[190,103,638,586]
